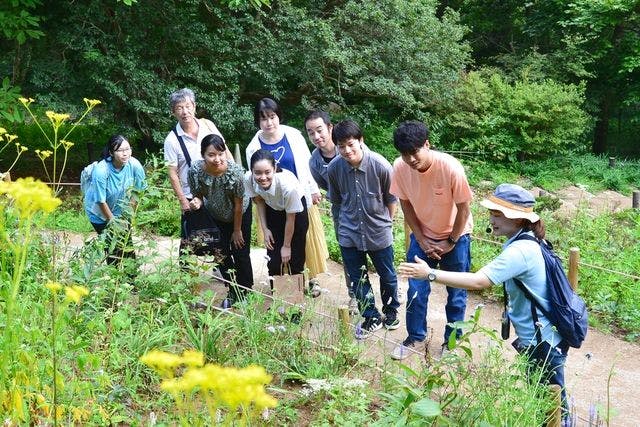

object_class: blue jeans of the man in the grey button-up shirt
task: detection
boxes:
[340,246,400,319]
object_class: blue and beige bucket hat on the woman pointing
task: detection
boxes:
[480,184,540,222]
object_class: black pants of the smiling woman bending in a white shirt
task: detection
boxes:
[266,197,309,276]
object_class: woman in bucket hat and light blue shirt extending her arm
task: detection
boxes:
[398,184,567,413]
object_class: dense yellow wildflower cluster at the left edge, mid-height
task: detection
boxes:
[0,177,62,218]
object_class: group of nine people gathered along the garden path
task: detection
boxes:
[85,88,567,414]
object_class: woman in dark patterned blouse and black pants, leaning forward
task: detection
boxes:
[189,134,253,308]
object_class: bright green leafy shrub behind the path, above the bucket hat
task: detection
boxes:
[441,72,588,162]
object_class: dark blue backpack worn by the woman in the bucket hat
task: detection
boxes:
[514,233,589,348]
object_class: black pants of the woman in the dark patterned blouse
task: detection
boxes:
[216,203,253,300]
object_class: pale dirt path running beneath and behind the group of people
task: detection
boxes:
[57,234,640,426]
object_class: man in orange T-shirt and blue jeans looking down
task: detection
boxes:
[390,121,473,360]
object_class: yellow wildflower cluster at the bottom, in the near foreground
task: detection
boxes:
[140,350,278,410]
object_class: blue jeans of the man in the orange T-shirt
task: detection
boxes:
[407,234,471,343]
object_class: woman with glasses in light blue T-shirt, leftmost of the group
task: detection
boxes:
[84,135,146,264]
